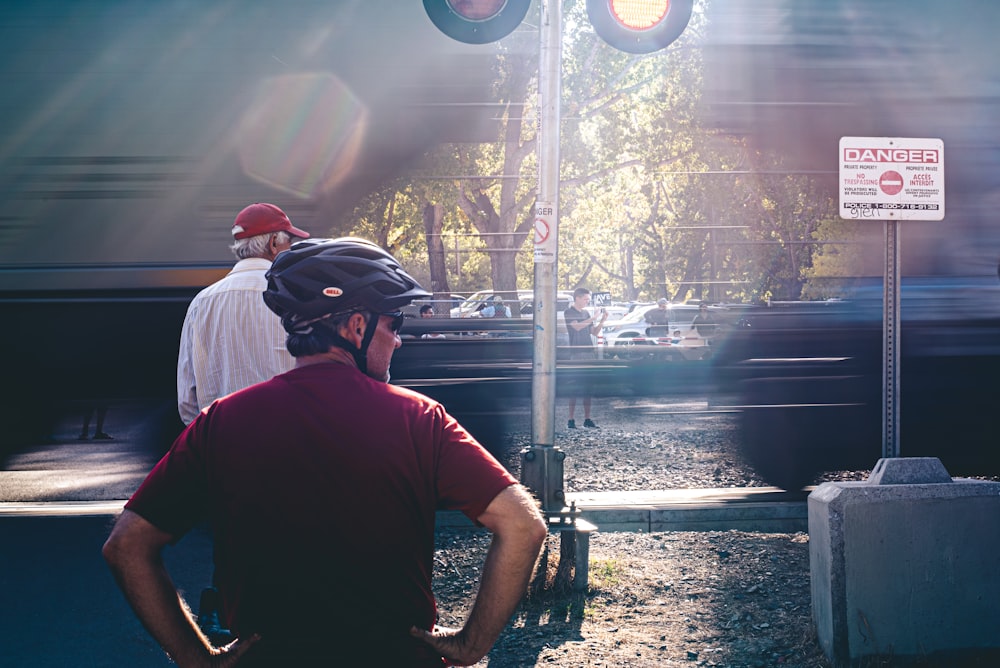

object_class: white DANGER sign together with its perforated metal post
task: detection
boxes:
[838,137,944,458]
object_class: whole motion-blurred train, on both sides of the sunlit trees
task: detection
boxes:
[0,0,1000,487]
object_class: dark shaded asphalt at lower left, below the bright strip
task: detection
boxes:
[0,512,212,668]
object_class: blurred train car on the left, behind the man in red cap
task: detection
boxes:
[0,0,508,454]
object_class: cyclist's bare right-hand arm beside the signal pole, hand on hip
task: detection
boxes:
[411,485,548,666]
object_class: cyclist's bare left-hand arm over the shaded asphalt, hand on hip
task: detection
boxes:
[102,510,257,666]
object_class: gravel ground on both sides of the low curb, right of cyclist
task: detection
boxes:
[435,399,844,668]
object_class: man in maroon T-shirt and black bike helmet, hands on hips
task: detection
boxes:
[104,239,546,666]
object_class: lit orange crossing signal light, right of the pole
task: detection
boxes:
[587,0,694,53]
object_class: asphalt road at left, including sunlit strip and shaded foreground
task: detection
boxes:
[0,402,205,668]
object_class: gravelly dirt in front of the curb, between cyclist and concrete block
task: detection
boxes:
[436,530,830,668]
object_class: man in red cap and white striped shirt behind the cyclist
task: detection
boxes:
[177,203,309,424]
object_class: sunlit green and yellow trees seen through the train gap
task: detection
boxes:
[344,0,844,301]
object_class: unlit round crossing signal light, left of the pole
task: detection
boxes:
[424,0,531,44]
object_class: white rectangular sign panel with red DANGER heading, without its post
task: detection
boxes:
[839,137,944,220]
